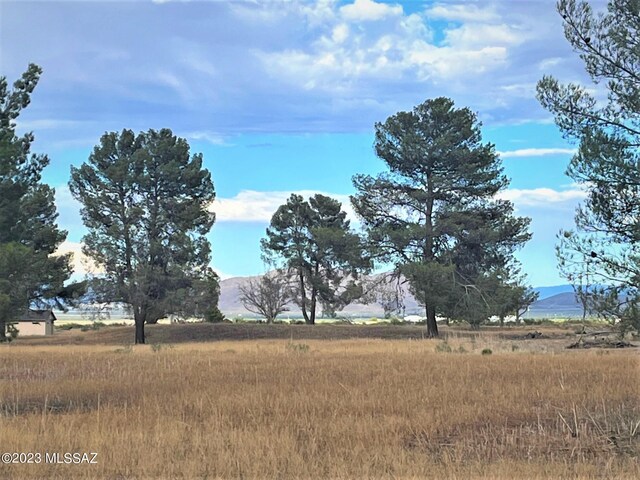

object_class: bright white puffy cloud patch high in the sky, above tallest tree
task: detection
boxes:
[256,0,530,94]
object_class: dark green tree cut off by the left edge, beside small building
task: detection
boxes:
[0,64,77,340]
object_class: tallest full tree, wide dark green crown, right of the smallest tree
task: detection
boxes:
[352,98,530,337]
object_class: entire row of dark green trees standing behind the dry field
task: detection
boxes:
[0,0,640,343]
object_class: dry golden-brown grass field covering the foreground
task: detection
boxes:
[0,326,640,479]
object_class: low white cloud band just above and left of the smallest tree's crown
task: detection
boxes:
[211,190,356,223]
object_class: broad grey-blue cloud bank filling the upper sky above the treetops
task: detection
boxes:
[1,0,584,143]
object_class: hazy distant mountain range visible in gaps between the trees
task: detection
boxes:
[219,276,582,318]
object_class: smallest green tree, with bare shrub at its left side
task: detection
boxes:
[262,194,371,324]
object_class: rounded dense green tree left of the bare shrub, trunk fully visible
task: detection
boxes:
[69,129,219,343]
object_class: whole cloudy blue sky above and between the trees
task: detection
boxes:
[0,0,604,286]
